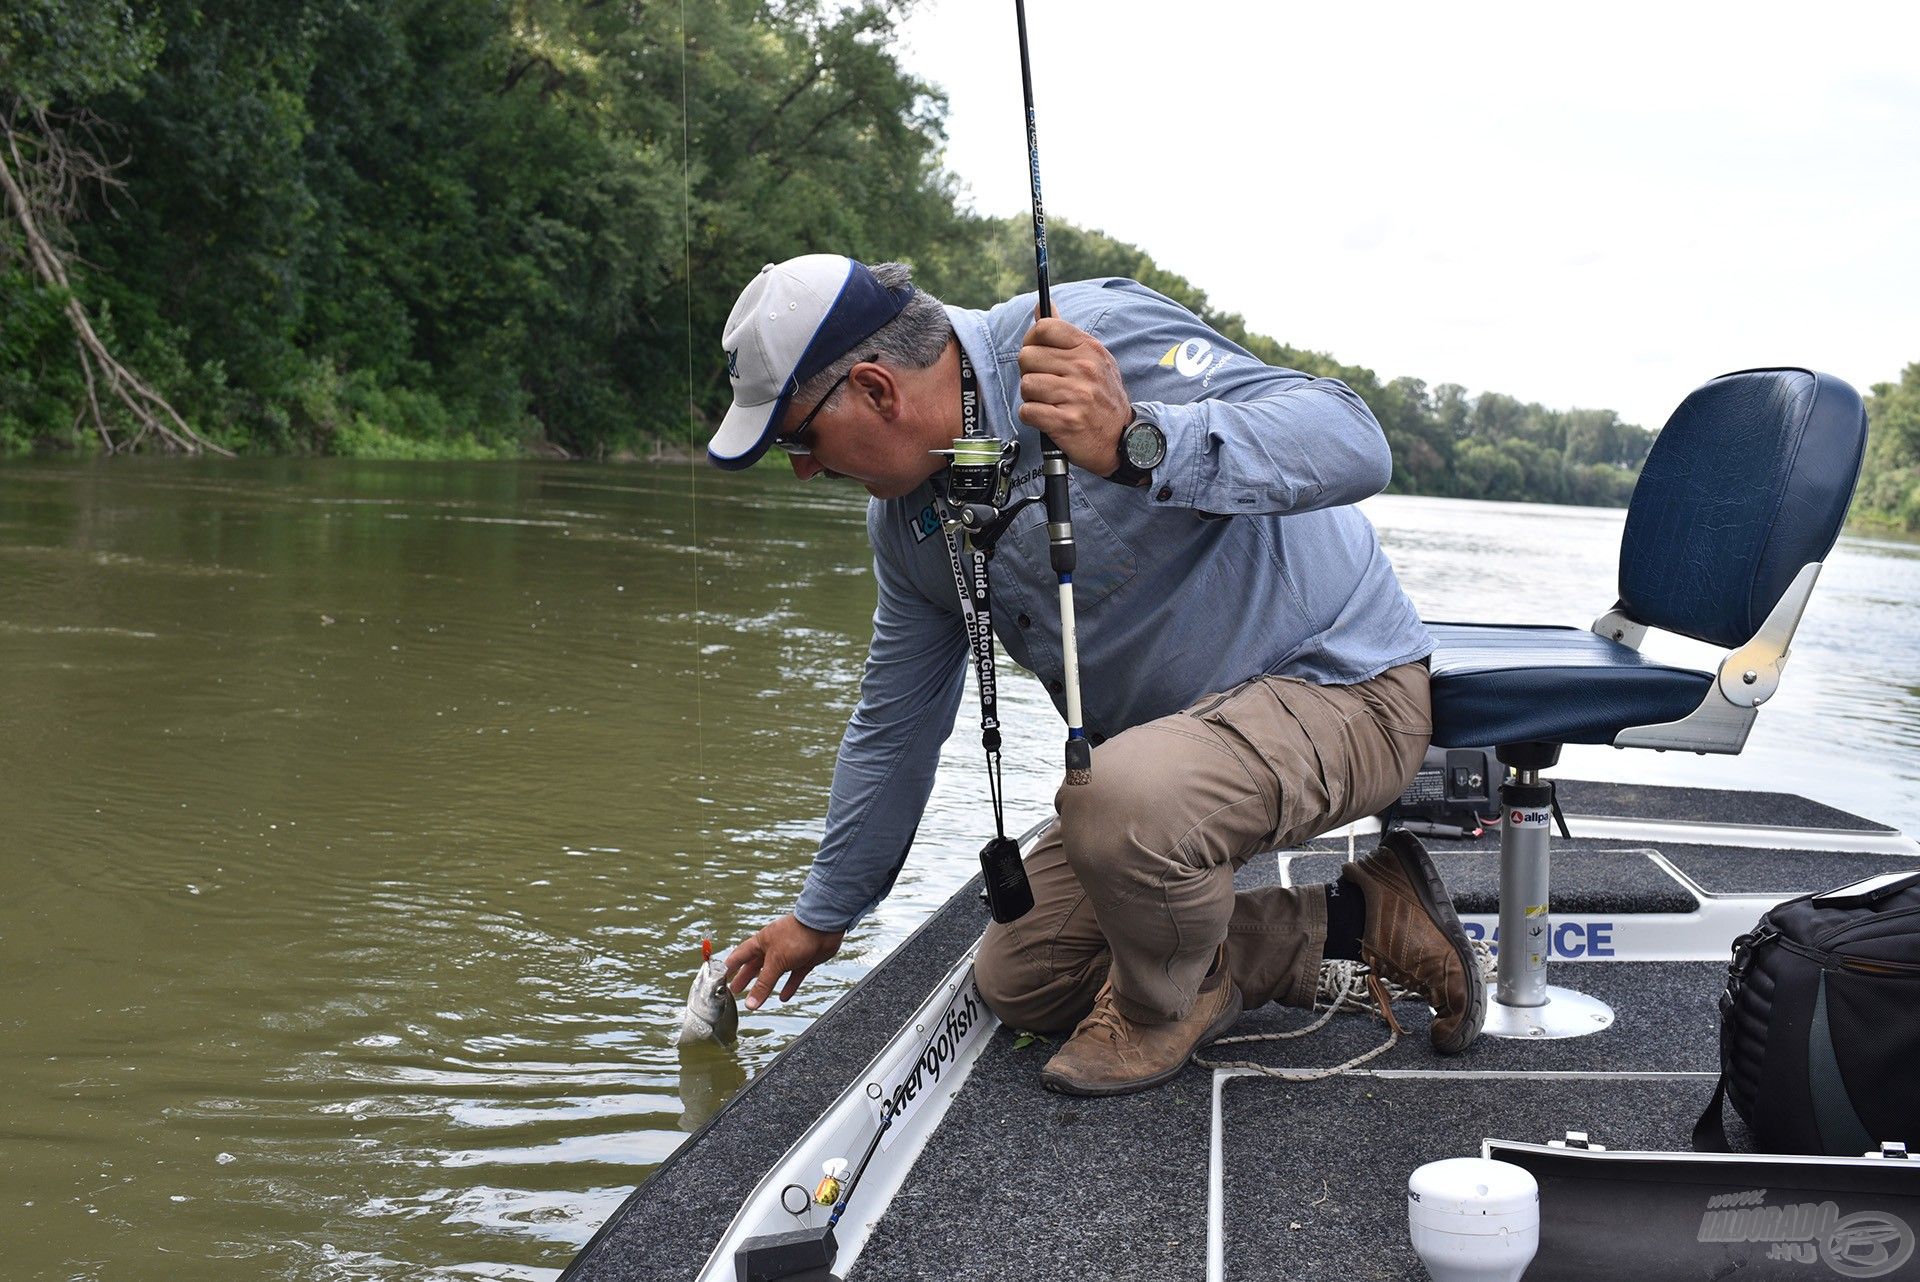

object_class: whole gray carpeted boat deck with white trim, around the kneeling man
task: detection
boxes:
[564,781,1914,1282]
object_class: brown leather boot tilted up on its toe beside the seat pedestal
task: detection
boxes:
[1340,829,1486,1056]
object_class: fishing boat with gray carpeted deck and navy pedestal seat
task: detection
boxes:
[563,370,1920,1282]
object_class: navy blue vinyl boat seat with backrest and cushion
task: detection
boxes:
[1428,368,1866,752]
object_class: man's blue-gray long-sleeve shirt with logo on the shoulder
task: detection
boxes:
[795,278,1432,931]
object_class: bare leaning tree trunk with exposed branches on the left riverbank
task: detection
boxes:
[0,100,232,457]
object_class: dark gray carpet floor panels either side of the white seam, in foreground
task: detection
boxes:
[849,962,1726,1282]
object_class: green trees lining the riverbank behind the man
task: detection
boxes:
[0,0,1920,520]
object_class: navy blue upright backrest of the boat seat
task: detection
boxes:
[1620,368,1866,649]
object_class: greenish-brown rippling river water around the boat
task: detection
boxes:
[0,461,1920,1282]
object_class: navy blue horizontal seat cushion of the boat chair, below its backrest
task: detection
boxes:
[1427,624,1713,748]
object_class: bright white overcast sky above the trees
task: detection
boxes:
[900,0,1920,428]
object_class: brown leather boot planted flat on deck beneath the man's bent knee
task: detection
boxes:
[1041,950,1240,1096]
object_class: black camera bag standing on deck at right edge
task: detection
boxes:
[1693,873,1920,1157]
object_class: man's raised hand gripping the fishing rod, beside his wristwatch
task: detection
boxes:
[1020,317,1133,476]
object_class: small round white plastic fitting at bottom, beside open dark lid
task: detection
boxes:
[1407,1157,1540,1282]
